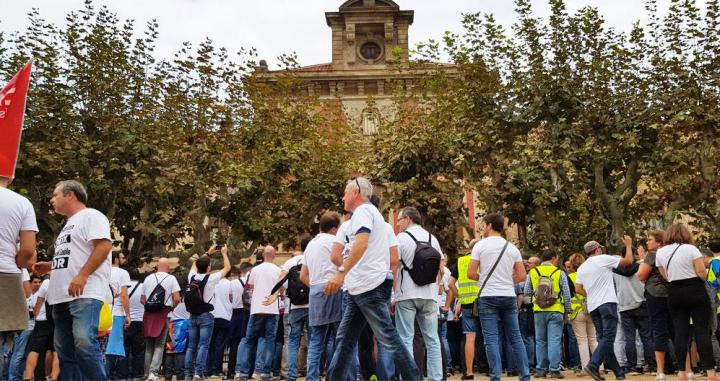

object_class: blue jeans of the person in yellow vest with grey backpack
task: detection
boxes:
[535,311,563,373]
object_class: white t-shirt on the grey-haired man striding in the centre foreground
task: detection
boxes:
[345,202,390,295]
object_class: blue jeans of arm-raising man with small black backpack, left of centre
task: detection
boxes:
[185,312,215,378]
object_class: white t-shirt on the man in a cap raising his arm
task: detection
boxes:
[575,254,620,312]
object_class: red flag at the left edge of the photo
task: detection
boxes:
[0,60,32,179]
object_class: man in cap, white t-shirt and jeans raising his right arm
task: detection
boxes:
[575,236,634,381]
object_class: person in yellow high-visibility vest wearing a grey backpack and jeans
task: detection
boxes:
[524,246,572,378]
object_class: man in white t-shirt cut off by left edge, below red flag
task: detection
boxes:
[0,177,38,332]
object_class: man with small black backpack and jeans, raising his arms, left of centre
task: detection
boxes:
[184,245,230,379]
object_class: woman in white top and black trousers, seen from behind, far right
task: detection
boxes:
[656,224,716,380]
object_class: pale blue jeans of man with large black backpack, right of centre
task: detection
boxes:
[395,299,445,381]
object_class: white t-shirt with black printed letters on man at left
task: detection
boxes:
[48,208,112,305]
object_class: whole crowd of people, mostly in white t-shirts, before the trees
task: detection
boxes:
[0,177,720,381]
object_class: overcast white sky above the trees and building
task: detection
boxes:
[0,0,704,66]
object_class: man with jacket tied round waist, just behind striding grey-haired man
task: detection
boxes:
[300,212,342,381]
